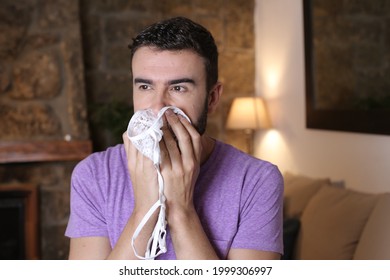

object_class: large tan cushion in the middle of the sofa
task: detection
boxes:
[295,186,379,260]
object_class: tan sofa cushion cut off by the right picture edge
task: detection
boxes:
[354,194,390,260]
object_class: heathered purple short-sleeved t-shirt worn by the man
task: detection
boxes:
[65,141,283,259]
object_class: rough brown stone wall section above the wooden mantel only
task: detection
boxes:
[0,0,89,140]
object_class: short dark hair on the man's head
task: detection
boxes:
[129,17,218,91]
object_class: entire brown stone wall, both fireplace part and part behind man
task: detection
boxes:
[0,0,254,259]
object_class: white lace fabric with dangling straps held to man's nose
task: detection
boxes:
[127,106,190,260]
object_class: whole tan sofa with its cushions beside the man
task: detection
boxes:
[283,172,390,260]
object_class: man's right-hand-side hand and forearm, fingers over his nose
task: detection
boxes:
[152,110,218,259]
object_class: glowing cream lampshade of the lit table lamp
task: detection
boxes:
[226,96,271,130]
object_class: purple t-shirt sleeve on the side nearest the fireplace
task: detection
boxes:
[65,157,108,238]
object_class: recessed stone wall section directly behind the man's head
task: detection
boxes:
[81,0,255,150]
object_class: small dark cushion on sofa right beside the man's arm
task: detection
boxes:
[282,218,300,260]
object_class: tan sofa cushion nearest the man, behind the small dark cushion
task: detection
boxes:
[283,172,330,218]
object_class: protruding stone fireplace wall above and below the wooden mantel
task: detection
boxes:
[0,0,89,259]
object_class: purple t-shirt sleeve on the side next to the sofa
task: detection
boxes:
[231,165,284,254]
